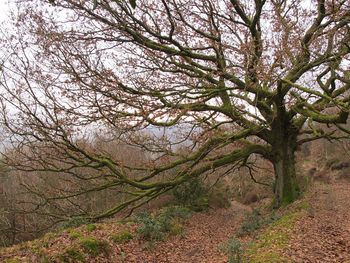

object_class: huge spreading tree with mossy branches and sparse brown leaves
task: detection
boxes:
[1,0,350,218]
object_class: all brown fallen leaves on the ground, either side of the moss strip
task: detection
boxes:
[0,181,350,263]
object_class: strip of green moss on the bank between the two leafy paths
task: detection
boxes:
[244,210,303,263]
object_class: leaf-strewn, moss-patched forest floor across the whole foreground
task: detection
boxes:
[0,181,350,263]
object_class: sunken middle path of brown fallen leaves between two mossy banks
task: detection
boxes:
[111,202,248,263]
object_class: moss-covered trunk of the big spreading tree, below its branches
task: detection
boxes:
[273,136,299,208]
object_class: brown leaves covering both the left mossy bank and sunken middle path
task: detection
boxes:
[0,202,249,263]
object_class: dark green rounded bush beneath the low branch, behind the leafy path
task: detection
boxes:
[173,178,209,211]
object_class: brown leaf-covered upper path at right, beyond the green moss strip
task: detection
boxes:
[286,181,350,263]
